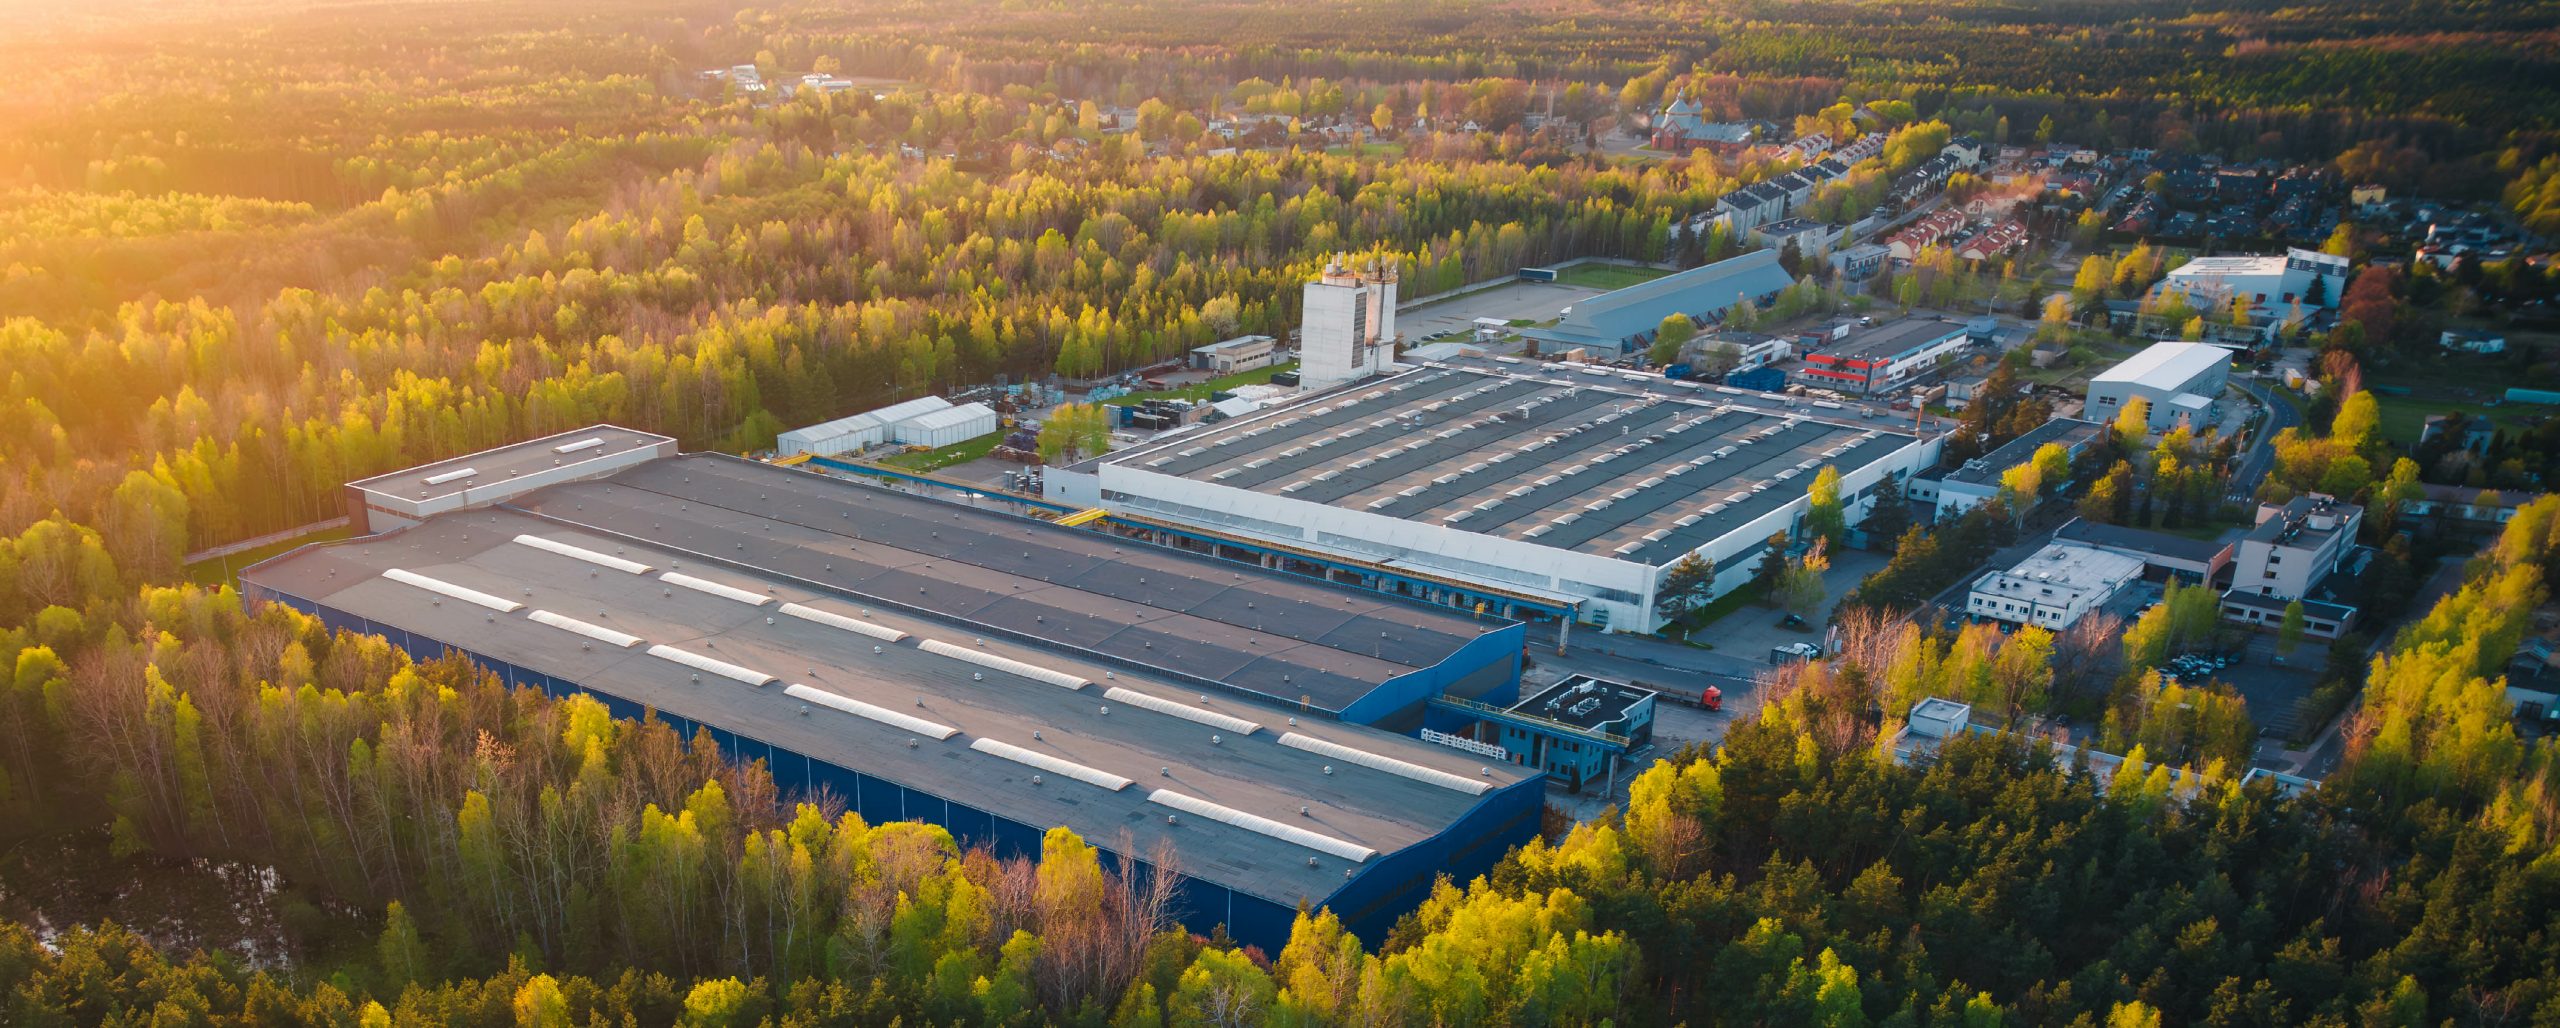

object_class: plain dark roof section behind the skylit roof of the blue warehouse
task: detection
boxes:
[517,455,1510,713]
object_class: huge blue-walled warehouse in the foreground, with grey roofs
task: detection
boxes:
[243,439,1544,951]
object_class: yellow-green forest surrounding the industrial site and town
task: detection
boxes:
[0,0,2560,1025]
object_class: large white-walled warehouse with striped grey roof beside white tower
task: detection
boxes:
[1044,358,1938,632]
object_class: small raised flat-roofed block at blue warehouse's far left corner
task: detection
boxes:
[343,424,676,532]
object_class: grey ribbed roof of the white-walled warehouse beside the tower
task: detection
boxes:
[1106,361,1915,565]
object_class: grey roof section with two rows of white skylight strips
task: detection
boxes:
[243,506,1521,905]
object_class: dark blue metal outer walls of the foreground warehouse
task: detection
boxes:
[241,580,1544,954]
